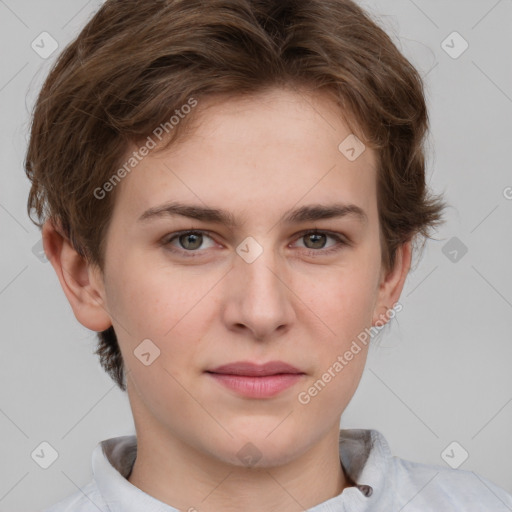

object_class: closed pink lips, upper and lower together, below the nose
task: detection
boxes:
[207,361,304,398]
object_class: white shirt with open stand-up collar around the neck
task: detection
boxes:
[43,429,512,512]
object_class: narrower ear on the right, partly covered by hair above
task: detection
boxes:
[372,241,412,325]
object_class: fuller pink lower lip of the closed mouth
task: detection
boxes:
[208,373,304,398]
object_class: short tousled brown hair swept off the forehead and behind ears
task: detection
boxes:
[25,0,445,390]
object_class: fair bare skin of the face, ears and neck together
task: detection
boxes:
[43,89,411,512]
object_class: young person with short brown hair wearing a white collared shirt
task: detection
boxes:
[26,0,512,512]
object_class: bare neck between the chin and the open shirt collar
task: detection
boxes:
[128,425,352,512]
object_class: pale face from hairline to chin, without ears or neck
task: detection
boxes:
[72,89,406,465]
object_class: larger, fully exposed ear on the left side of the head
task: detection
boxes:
[42,221,112,332]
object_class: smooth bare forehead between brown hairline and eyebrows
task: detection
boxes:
[110,89,376,224]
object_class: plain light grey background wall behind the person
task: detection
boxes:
[0,0,512,512]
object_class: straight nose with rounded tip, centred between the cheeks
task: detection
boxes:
[222,241,295,341]
